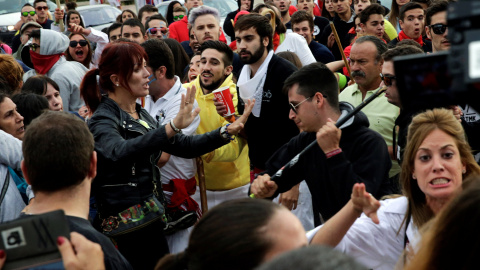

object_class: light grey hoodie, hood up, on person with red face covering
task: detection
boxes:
[22,29,88,112]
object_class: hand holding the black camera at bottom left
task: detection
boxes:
[57,232,105,270]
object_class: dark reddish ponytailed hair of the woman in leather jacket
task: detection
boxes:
[80,41,148,112]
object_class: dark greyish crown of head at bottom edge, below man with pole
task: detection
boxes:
[256,246,366,270]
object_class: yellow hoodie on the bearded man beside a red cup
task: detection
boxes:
[184,74,250,190]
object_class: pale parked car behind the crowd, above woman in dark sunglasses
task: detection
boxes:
[77,4,122,30]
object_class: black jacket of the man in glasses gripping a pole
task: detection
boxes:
[267,102,392,225]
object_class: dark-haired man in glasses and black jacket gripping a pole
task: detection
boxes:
[250,63,392,226]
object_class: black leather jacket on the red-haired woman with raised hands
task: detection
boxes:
[88,97,228,217]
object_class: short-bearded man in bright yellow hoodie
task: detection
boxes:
[184,40,250,210]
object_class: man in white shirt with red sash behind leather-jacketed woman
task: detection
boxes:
[141,39,200,253]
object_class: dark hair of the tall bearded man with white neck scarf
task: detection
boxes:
[235,13,273,51]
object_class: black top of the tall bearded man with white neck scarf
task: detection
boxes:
[237,54,298,169]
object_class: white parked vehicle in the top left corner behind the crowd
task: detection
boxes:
[0,0,57,44]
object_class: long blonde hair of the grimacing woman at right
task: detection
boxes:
[400,109,480,228]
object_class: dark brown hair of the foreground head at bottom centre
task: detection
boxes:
[155,199,285,270]
